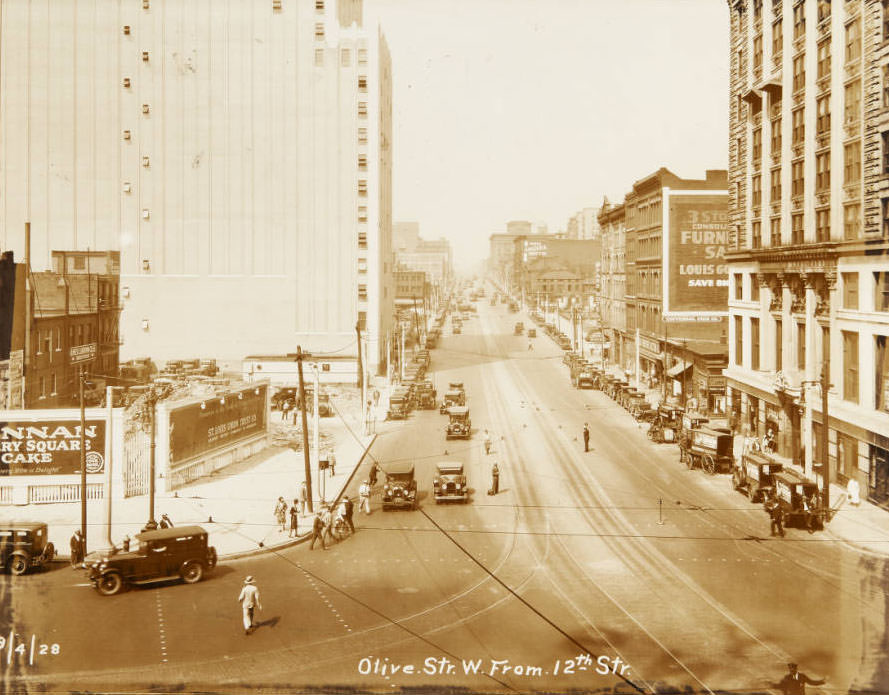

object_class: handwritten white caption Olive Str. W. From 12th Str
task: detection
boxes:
[358,654,630,679]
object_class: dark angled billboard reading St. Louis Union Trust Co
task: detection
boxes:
[170,384,268,464]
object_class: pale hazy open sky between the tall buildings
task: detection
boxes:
[365,0,729,269]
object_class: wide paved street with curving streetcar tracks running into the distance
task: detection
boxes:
[0,292,889,693]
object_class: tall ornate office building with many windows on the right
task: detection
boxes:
[726,0,889,503]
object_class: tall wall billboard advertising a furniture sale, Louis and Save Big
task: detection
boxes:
[663,190,729,315]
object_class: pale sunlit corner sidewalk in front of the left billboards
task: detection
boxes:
[27,400,382,559]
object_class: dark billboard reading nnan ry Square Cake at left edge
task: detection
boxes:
[0,419,105,476]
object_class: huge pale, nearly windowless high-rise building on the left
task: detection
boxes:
[0,0,394,376]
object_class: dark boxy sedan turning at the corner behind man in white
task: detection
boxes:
[85,526,217,596]
